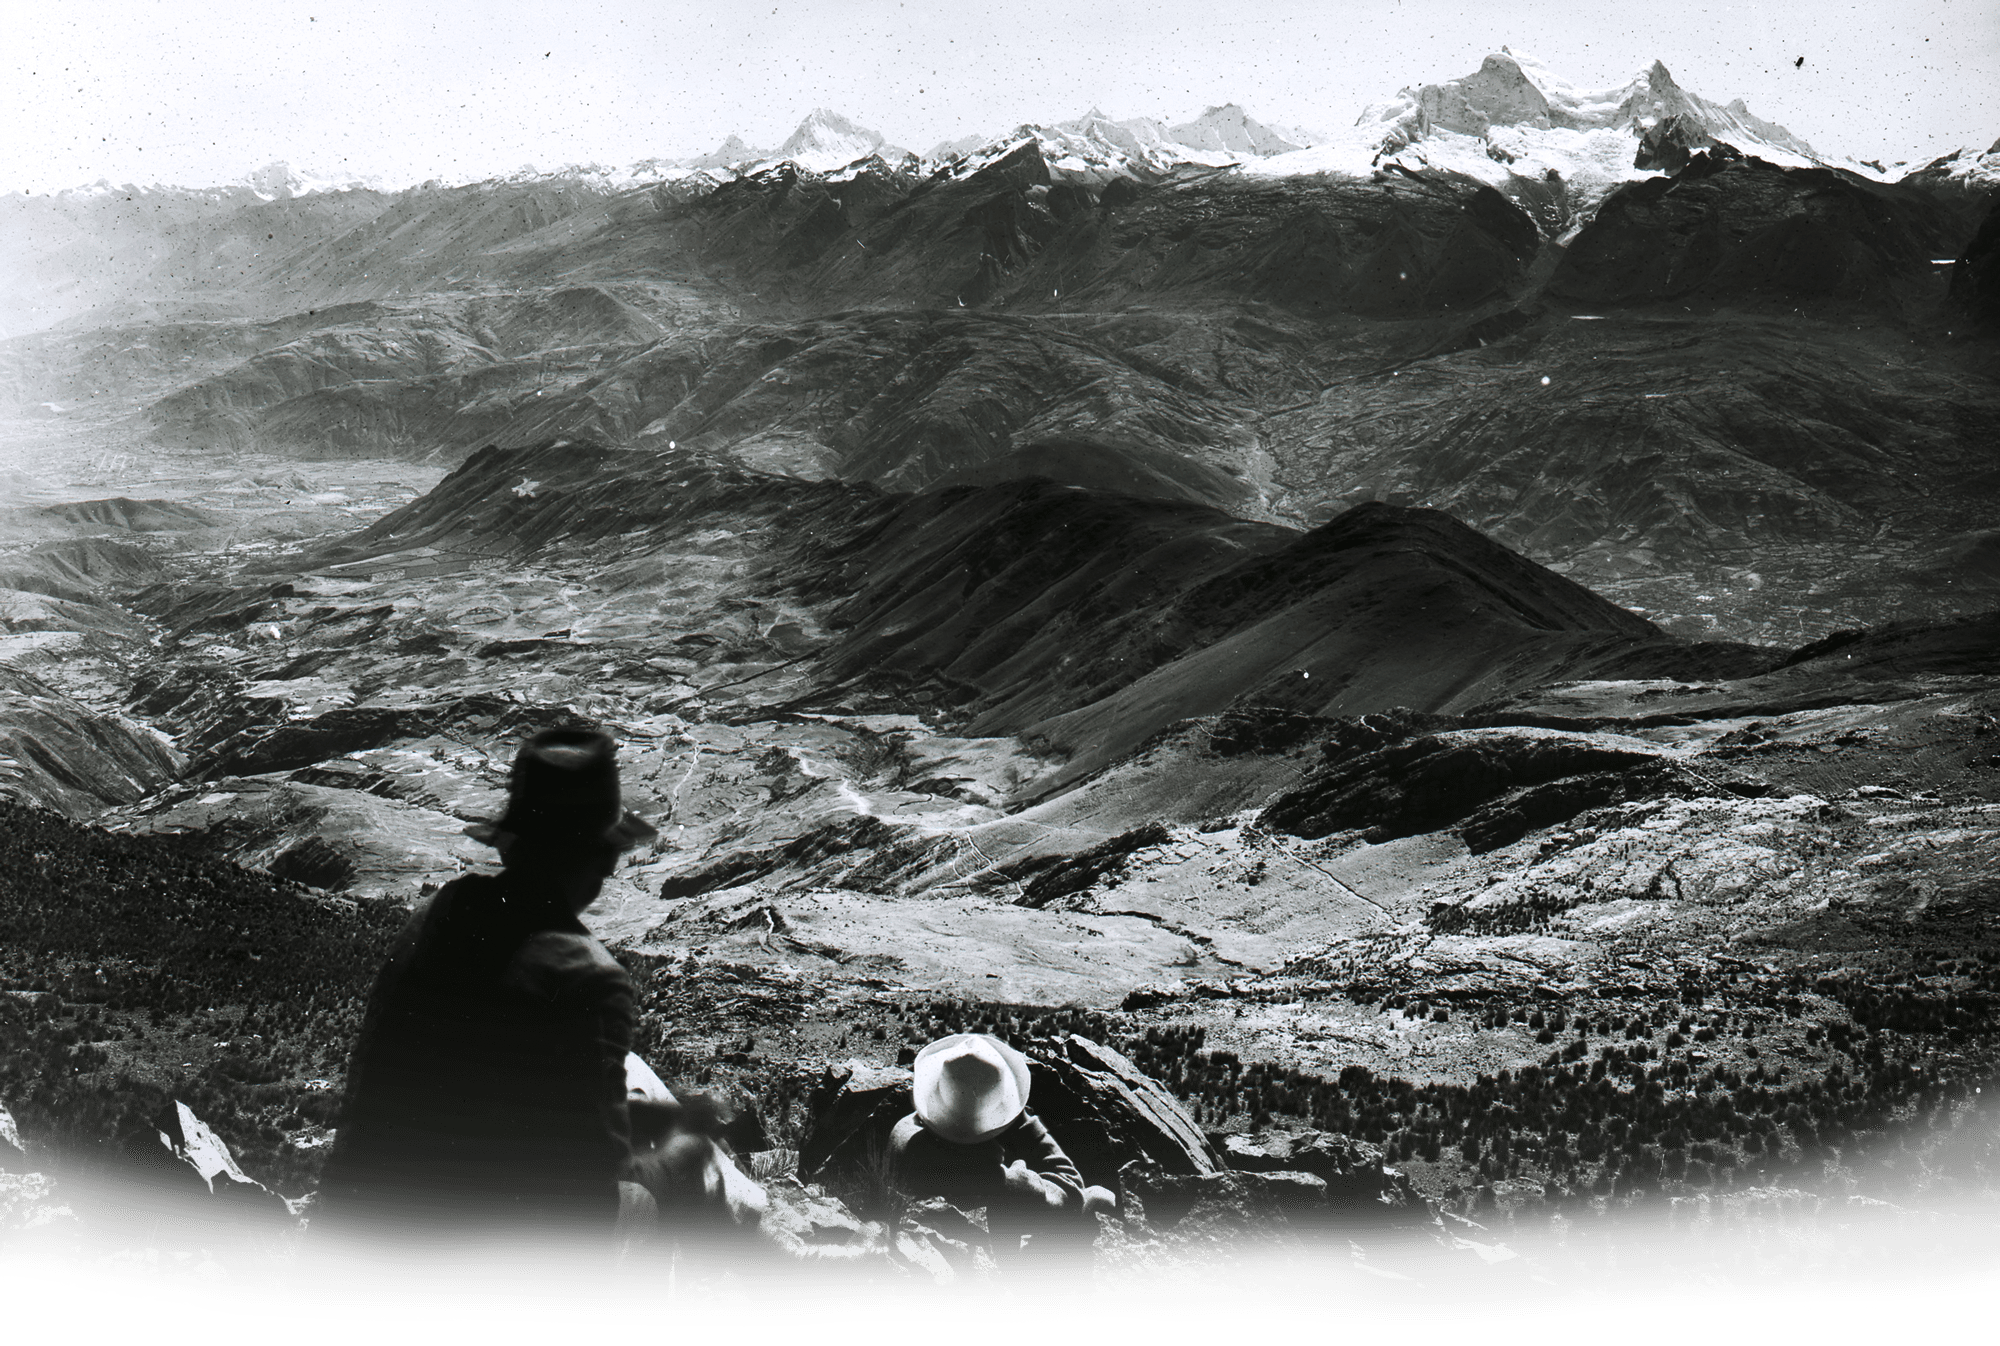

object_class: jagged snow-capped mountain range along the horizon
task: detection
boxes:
[11,48,2000,346]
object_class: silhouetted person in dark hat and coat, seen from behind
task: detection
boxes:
[300,730,656,1282]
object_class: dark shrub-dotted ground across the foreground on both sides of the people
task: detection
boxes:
[0,804,2000,1286]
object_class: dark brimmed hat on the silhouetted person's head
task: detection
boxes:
[466,730,660,850]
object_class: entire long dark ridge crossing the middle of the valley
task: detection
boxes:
[342,444,1762,792]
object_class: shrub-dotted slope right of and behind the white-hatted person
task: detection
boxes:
[892,976,2000,1288]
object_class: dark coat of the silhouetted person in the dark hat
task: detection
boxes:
[312,874,634,1270]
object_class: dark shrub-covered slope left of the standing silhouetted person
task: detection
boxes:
[0,802,406,1196]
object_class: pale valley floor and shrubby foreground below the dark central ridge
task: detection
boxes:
[0,420,2000,1292]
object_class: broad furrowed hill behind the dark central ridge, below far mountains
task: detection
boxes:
[516,310,1258,512]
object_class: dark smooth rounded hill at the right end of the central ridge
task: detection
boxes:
[944,494,1712,788]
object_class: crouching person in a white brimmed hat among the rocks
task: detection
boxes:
[890,1032,1116,1282]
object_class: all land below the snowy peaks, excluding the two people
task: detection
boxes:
[0,131,2000,1304]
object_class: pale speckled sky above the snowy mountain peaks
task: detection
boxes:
[0,0,2000,192]
